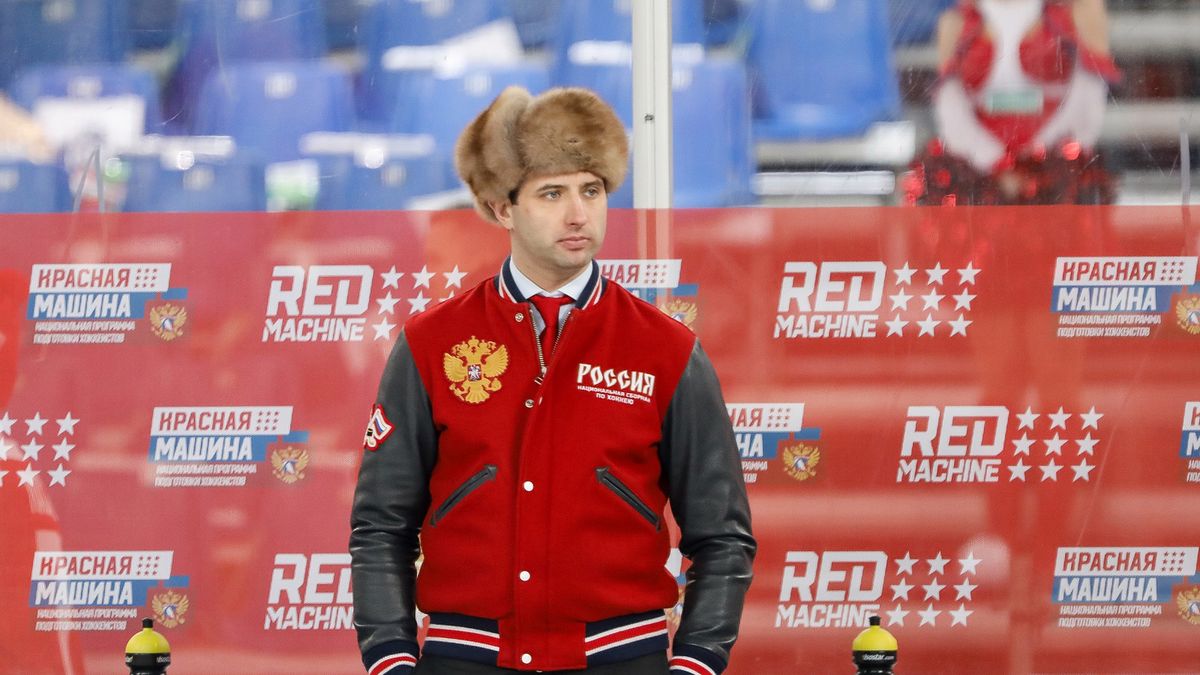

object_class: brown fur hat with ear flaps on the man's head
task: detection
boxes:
[455,86,629,222]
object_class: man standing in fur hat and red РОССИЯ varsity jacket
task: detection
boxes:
[350,88,755,675]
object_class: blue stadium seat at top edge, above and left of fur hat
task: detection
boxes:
[358,0,512,124]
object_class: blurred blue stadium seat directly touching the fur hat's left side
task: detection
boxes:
[389,65,550,185]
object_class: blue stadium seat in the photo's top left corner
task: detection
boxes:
[0,0,130,89]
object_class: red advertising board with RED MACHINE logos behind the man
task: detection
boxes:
[0,207,1200,675]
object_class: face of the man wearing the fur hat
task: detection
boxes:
[493,172,608,291]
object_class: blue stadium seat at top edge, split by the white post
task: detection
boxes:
[553,0,704,83]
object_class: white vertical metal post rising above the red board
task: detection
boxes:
[631,0,673,209]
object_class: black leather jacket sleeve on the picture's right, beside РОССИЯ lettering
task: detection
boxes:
[659,341,757,667]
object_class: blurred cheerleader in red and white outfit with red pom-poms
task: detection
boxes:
[905,0,1120,204]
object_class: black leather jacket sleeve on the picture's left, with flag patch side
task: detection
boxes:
[350,334,437,668]
